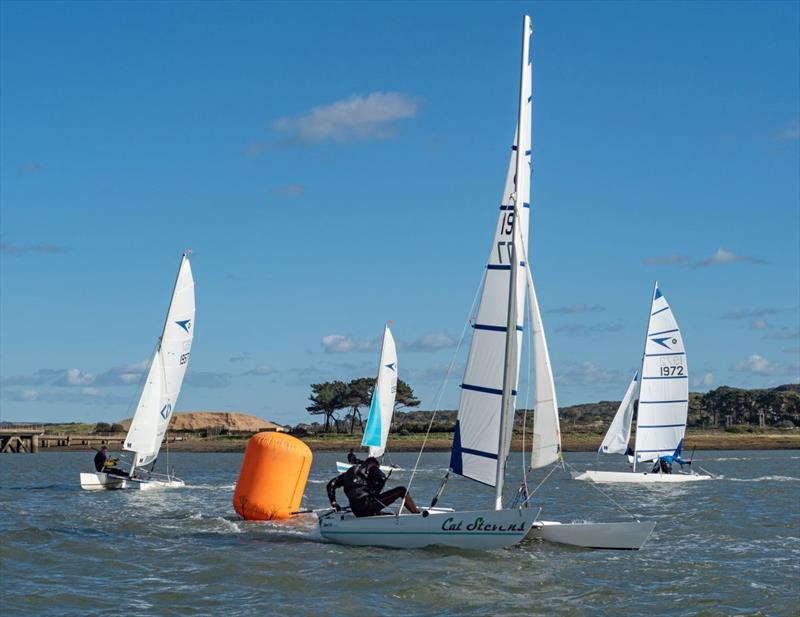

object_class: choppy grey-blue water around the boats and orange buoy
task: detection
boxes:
[0,451,800,615]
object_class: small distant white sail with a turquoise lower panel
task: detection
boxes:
[361,325,397,458]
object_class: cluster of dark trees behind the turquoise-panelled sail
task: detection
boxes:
[306,377,420,433]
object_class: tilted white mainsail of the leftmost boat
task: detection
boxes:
[123,254,195,468]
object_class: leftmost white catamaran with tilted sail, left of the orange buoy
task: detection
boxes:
[81,253,195,490]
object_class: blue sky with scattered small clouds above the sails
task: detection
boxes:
[0,2,800,423]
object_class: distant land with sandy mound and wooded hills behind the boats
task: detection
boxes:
[0,384,800,452]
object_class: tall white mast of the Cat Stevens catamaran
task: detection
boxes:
[494,15,531,510]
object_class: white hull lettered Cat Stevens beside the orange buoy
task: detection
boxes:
[319,508,538,550]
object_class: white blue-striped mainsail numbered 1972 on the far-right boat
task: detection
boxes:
[634,282,689,464]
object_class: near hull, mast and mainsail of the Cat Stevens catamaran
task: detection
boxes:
[319,16,538,549]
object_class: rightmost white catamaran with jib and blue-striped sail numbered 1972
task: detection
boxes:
[575,282,711,484]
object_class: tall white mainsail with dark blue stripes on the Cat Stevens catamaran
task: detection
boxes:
[450,17,531,486]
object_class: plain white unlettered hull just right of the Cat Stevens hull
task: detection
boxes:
[526,520,656,551]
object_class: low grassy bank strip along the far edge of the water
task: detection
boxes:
[40,430,800,452]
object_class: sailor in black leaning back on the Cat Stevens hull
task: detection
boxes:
[327,456,419,516]
